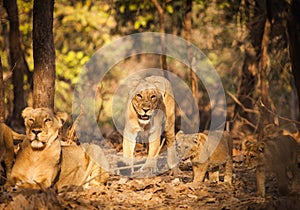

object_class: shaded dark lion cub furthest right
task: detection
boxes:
[243,135,297,196]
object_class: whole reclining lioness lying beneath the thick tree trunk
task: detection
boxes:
[10,107,108,189]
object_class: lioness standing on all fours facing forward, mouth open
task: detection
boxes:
[123,76,177,172]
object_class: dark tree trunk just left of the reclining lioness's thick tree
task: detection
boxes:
[4,0,29,129]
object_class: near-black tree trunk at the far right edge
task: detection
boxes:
[287,1,300,120]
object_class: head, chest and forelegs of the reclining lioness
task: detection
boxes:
[10,107,65,188]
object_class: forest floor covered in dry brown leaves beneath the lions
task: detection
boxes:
[0,158,300,210]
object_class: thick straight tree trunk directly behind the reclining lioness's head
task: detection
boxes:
[33,0,55,109]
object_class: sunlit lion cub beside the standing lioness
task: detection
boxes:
[176,131,232,183]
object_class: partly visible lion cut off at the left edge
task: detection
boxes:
[0,123,14,184]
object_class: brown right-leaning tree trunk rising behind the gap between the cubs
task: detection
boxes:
[232,0,266,133]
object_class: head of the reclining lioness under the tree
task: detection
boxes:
[22,107,66,150]
